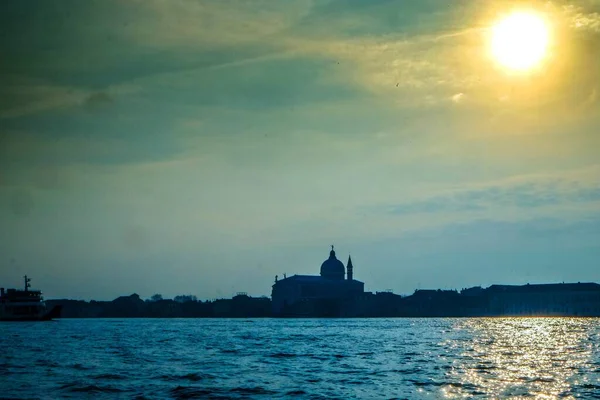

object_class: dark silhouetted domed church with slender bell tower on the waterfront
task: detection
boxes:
[271,246,365,316]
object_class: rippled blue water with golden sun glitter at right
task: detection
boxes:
[0,318,600,399]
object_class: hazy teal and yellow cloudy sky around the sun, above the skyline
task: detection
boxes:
[0,0,600,300]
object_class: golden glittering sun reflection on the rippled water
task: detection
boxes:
[443,318,600,399]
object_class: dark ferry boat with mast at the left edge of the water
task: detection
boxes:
[0,275,61,321]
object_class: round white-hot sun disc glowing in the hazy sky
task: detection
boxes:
[491,12,549,71]
